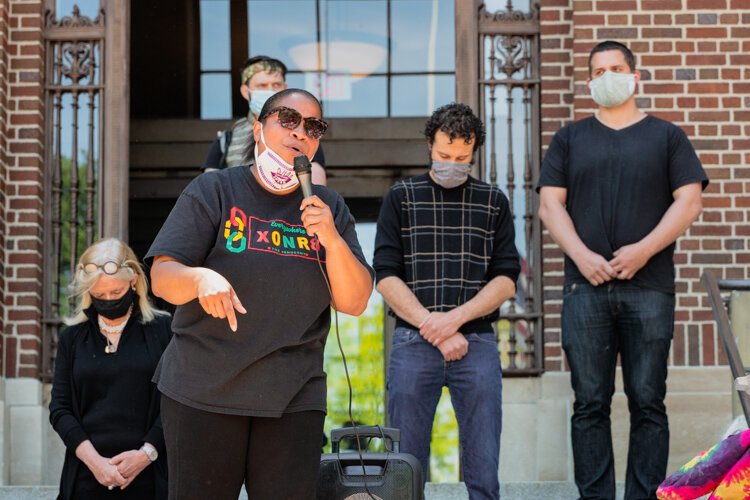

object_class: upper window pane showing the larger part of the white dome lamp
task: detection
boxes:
[320,0,388,75]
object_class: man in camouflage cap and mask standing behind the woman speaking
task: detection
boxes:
[201,56,326,186]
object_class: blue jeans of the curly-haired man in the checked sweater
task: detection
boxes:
[388,328,502,500]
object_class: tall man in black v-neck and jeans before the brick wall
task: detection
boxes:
[537,41,708,499]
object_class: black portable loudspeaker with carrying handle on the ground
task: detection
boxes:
[317,426,424,500]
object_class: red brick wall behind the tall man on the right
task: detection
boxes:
[542,0,750,370]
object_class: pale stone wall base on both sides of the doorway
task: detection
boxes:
[0,367,732,485]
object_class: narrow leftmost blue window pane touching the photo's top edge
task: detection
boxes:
[200,0,231,71]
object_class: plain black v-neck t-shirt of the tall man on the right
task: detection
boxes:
[537,116,708,293]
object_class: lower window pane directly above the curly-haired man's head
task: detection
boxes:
[391,75,456,116]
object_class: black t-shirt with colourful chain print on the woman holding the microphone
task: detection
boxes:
[146,167,372,417]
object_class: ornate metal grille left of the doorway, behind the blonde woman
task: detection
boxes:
[41,3,105,380]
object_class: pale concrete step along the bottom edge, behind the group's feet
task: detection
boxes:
[0,481,623,500]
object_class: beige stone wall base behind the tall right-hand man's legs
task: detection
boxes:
[500,367,732,482]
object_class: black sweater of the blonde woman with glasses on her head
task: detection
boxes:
[49,308,172,499]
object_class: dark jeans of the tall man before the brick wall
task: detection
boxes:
[562,281,675,500]
